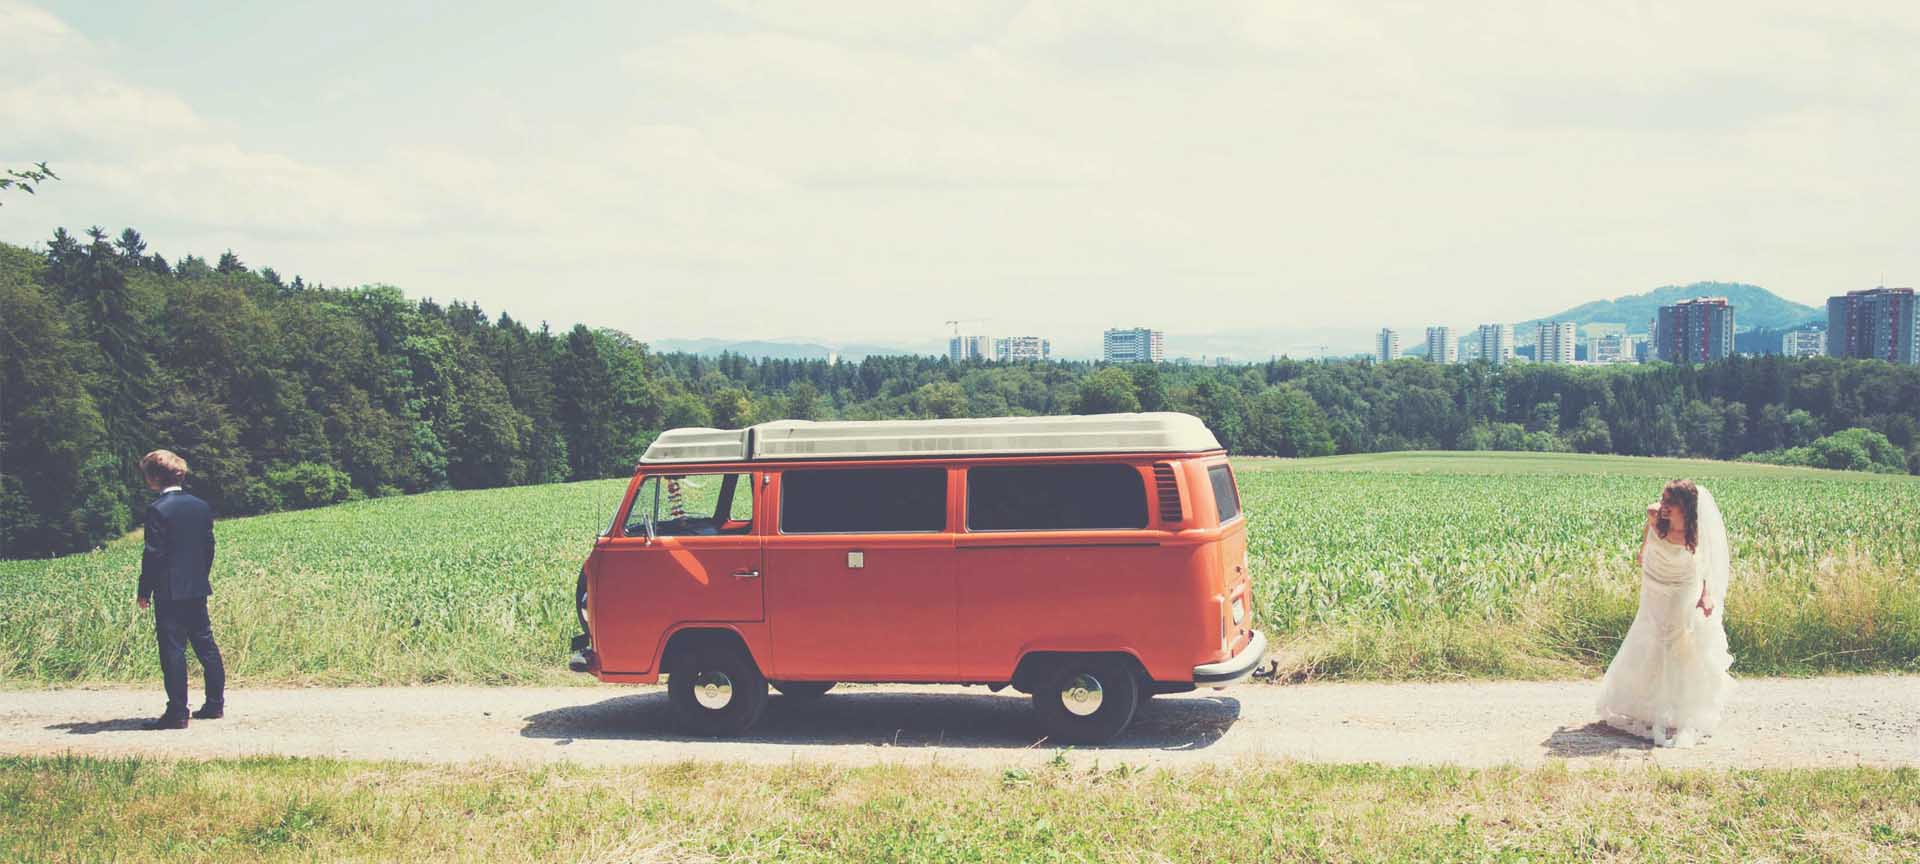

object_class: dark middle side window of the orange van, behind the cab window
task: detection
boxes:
[780,468,947,534]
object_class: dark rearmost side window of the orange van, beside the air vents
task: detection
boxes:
[966,463,1146,532]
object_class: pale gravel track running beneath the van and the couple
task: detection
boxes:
[0,678,1920,768]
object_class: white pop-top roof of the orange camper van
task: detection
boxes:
[639,411,1221,465]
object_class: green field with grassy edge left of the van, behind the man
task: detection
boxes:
[0,480,626,684]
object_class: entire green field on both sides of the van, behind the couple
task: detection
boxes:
[0,453,1920,685]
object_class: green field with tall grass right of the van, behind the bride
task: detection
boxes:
[1242,455,1920,678]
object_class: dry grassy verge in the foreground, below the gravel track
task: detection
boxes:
[0,756,1920,862]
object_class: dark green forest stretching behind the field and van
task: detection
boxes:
[0,228,1920,557]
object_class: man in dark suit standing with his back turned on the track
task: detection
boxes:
[138,449,227,730]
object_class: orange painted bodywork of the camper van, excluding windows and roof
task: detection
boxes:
[588,451,1252,684]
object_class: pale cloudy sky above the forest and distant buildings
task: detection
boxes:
[0,0,1920,355]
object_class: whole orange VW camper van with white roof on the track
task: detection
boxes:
[572,413,1267,743]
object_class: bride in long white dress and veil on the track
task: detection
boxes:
[1599,480,1734,747]
